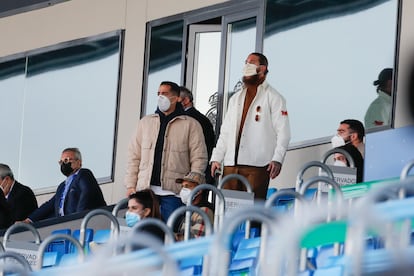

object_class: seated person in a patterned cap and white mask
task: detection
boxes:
[176,172,214,240]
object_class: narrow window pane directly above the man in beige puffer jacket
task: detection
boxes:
[146,20,184,113]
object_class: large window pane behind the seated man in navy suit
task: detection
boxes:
[0,35,120,189]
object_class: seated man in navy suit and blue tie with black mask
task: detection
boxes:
[24,148,106,223]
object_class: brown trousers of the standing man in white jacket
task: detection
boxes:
[223,165,270,200]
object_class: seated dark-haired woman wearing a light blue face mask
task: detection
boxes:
[125,189,164,242]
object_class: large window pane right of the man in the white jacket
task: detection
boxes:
[264,0,398,145]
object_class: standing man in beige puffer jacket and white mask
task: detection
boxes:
[125,81,208,221]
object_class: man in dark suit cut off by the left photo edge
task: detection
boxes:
[0,164,37,222]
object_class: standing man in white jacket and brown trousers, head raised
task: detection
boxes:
[210,53,290,199]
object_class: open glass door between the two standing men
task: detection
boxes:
[185,10,258,134]
